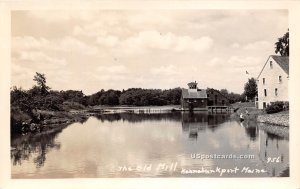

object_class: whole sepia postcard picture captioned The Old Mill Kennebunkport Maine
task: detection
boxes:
[0,1,299,188]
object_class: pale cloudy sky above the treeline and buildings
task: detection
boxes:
[11,9,288,95]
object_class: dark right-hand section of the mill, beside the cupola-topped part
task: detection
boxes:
[207,89,229,106]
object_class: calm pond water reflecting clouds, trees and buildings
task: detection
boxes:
[11,112,289,178]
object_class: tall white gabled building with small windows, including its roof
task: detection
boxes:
[256,55,289,109]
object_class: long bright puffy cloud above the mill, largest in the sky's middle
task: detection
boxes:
[97,30,214,55]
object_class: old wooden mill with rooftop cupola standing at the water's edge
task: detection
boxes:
[181,81,230,111]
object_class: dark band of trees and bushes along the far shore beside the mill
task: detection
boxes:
[11,73,244,112]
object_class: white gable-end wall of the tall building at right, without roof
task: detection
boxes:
[257,57,289,109]
